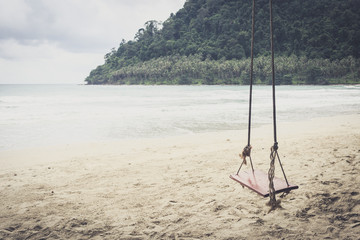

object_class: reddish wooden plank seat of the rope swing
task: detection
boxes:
[230,170,299,197]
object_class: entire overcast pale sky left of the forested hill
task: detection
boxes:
[0,0,185,84]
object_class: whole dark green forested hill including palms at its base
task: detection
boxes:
[85,0,360,84]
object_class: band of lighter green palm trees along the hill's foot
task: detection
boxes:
[89,55,360,85]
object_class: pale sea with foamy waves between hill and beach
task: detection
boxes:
[0,85,360,151]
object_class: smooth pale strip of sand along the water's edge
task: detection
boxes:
[0,114,360,170]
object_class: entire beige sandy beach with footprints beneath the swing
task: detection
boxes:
[0,114,360,239]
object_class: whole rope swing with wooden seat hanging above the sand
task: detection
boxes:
[230,0,298,202]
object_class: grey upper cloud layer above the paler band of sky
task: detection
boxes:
[0,0,183,51]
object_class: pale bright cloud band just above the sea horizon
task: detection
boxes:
[0,41,102,84]
